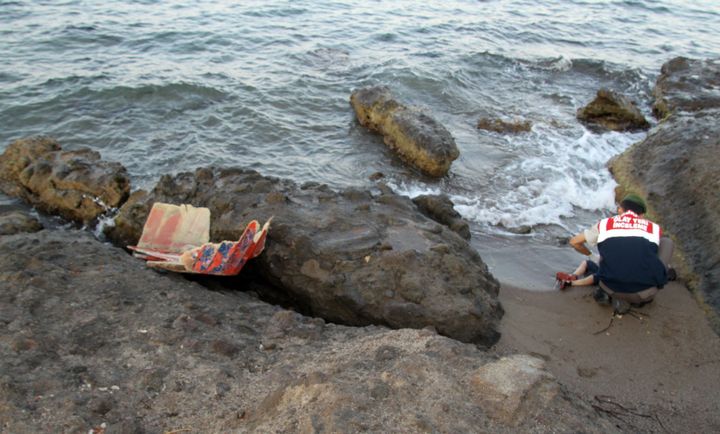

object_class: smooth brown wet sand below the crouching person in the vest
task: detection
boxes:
[494,276,720,433]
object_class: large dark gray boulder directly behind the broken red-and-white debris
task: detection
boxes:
[109,168,502,345]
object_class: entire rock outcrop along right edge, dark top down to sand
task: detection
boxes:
[610,58,720,333]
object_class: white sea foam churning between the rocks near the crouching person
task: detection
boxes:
[391,127,642,234]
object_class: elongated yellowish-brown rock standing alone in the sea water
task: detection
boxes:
[350,86,460,177]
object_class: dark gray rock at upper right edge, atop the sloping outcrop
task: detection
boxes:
[653,57,720,119]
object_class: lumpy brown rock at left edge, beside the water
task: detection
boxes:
[0,137,130,223]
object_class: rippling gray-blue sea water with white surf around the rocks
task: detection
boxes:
[0,0,720,288]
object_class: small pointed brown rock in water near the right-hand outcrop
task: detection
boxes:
[577,89,650,131]
